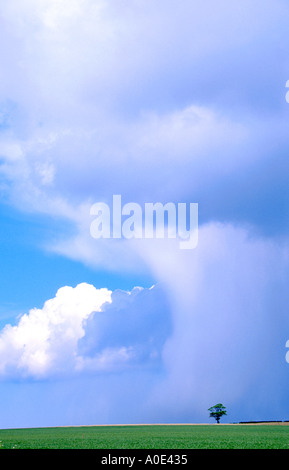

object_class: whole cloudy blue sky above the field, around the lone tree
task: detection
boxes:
[0,0,289,428]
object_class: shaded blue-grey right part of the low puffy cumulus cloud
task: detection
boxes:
[79,286,172,367]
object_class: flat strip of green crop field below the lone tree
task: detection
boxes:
[0,424,289,449]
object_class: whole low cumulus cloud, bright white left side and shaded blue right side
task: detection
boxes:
[0,283,170,378]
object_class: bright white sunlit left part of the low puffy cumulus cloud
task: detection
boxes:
[0,283,111,377]
